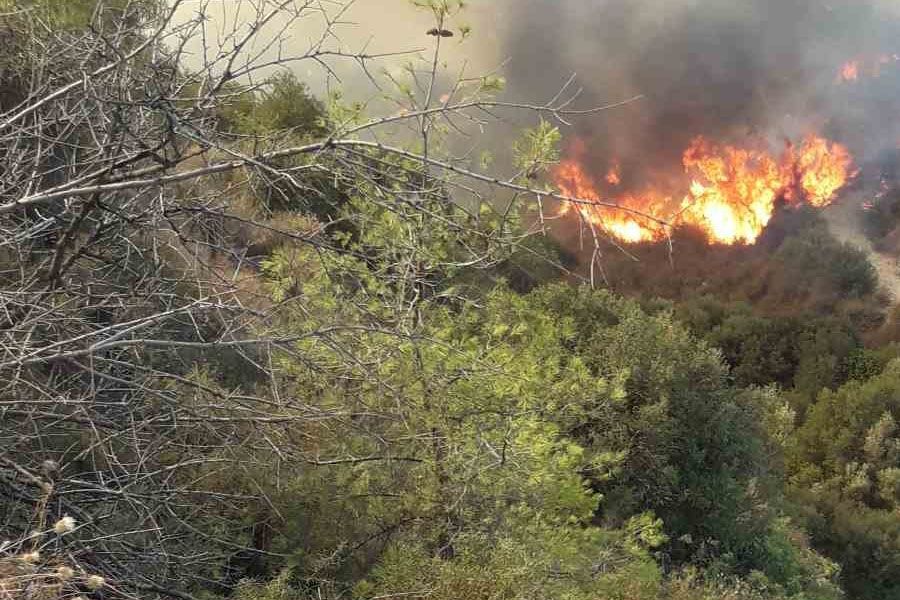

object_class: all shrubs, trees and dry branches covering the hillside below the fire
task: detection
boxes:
[0,0,900,600]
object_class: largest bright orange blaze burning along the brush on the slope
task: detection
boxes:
[554,136,854,244]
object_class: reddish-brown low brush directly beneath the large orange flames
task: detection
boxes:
[585,209,884,333]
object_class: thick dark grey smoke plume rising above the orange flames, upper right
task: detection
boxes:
[497,0,900,187]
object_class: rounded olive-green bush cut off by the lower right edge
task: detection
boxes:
[788,360,900,599]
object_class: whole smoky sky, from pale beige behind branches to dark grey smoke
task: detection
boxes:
[174,0,900,176]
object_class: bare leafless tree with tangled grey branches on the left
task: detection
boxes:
[0,0,652,598]
